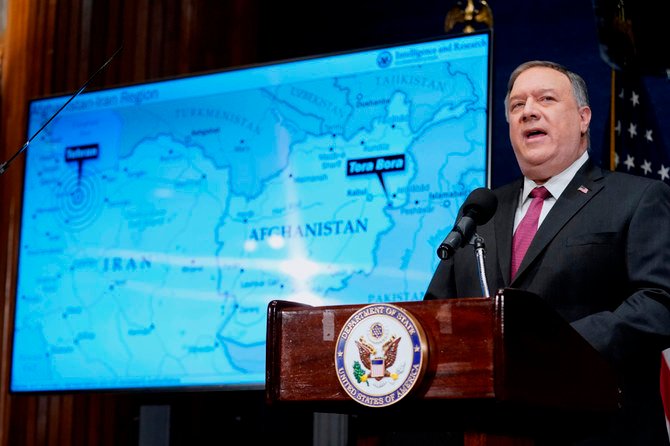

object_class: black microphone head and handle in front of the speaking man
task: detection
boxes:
[437,187,498,260]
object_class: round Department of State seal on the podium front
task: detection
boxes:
[335,304,428,407]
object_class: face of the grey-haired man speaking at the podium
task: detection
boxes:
[508,67,591,182]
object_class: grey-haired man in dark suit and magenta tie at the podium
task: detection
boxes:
[425,61,670,446]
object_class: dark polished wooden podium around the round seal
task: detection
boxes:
[265,289,619,446]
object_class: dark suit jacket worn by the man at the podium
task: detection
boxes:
[425,161,670,445]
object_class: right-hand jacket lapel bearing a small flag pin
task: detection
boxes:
[503,161,603,285]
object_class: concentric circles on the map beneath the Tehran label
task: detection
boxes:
[56,168,103,231]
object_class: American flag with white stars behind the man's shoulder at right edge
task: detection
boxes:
[609,70,670,438]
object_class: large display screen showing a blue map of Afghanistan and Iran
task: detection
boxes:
[11,29,491,392]
